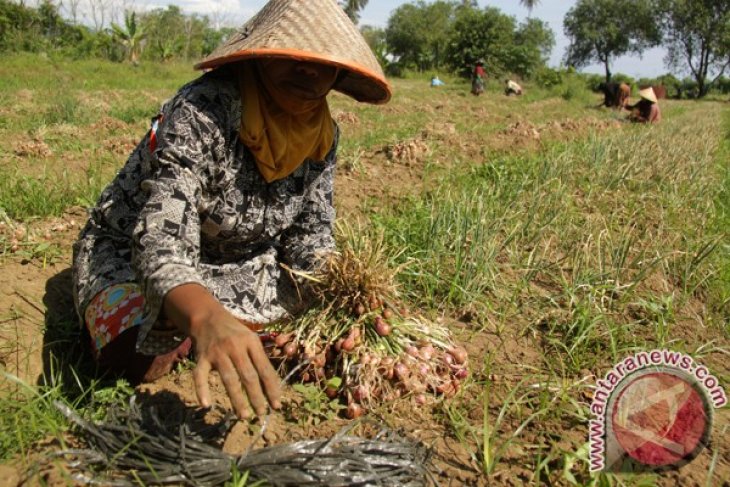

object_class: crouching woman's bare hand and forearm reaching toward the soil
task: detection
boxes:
[164,284,281,419]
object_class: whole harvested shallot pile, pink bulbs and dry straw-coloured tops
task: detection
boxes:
[272,223,468,418]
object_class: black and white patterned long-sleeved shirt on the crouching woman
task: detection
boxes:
[73,68,339,354]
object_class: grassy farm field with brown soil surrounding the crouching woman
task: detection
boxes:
[0,55,730,486]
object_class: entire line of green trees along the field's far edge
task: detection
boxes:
[0,0,730,96]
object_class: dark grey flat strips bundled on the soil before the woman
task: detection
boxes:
[56,397,436,486]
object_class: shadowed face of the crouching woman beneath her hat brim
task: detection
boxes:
[260,58,338,100]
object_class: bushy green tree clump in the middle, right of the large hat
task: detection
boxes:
[370,0,555,78]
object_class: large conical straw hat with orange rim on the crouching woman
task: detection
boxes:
[195,0,391,103]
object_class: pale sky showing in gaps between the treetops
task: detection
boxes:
[145,0,668,78]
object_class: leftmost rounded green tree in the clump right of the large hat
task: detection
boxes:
[385,0,456,71]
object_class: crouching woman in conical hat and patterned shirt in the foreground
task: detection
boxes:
[73,0,391,417]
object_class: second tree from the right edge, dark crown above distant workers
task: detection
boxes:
[563,0,660,81]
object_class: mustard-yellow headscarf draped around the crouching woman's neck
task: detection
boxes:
[239,63,334,183]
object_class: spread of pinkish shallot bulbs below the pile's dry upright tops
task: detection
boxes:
[267,298,468,418]
